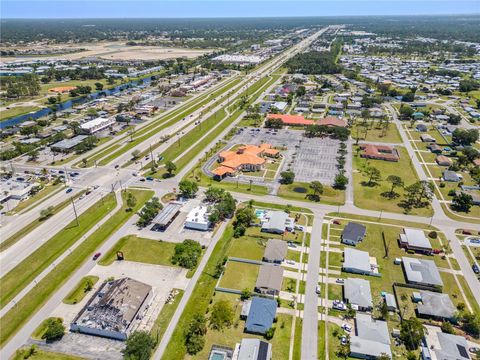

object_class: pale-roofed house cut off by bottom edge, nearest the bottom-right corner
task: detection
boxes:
[422,326,471,360]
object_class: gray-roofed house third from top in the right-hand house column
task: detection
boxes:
[417,291,456,320]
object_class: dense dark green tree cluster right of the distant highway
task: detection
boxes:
[286,40,342,75]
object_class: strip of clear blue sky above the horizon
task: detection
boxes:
[0,0,480,18]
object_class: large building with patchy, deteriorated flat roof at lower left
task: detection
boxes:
[70,278,152,340]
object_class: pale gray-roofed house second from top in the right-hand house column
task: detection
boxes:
[402,256,443,287]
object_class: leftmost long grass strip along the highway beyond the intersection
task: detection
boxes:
[99,79,241,165]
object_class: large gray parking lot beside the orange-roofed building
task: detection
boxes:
[226,128,340,184]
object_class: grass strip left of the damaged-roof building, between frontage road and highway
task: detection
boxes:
[0,190,153,346]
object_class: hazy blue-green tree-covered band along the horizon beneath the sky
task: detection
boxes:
[0,15,480,42]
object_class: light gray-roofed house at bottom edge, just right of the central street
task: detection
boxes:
[350,313,392,359]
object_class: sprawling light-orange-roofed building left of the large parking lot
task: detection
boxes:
[212,144,280,178]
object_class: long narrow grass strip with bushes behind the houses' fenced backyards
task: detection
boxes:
[162,224,233,360]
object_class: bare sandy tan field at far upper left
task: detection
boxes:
[2,42,214,62]
